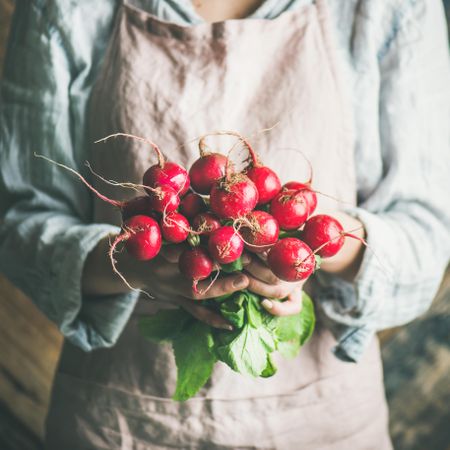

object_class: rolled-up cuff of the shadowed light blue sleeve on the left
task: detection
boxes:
[49,224,139,351]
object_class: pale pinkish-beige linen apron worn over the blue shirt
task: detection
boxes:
[47,1,391,450]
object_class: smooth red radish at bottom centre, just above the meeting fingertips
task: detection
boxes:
[208,226,244,264]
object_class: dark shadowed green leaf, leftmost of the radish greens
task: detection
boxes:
[138,309,192,342]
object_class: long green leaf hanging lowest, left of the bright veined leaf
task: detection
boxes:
[172,322,217,402]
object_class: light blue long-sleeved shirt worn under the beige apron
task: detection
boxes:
[0,0,450,361]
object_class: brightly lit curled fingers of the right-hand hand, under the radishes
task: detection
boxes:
[244,254,304,316]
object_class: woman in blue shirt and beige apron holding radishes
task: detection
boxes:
[0,0,450,450]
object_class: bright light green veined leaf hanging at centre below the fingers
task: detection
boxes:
[216,324,275,377]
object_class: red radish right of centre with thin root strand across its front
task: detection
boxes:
[238,211,280,253]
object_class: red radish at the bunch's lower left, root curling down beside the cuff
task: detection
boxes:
[115,216,162,261]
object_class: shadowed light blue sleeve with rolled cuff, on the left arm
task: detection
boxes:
[0,0,140,350]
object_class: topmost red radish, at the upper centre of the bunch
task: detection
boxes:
[189,152,227,194]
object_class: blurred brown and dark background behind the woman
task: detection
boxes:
[0,0,450,450]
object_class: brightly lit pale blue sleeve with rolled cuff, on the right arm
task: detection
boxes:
[318,0,450,361]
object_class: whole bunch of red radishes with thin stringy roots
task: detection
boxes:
[90,132,349,290]
